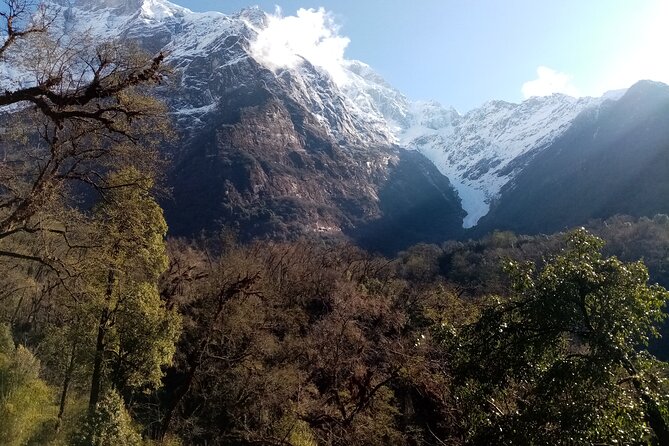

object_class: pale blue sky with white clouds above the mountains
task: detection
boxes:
[172,0,669,112]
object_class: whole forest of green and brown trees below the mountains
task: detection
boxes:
[0,0,669,446]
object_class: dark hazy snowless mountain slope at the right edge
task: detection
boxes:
[476,81,669,233]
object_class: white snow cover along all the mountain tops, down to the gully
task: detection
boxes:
[47,0,628,227]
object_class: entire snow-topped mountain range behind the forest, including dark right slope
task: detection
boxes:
[14,0,669,247]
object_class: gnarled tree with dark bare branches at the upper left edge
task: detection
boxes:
[0,0,167,270]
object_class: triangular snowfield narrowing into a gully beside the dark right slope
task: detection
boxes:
[399,94,615,228]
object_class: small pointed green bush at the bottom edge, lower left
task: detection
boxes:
[72,391,142,446]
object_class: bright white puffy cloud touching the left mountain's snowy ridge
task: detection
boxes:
[245,8,350,85]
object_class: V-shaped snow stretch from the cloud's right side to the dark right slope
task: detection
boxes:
[334,55,625,228]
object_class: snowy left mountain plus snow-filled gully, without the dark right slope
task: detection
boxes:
[8,0,668,249]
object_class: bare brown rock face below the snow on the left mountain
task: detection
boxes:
[166,92,397,237]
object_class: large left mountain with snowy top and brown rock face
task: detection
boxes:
[48,0,462,252]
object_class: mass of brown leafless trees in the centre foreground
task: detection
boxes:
[163,241,454,446]
